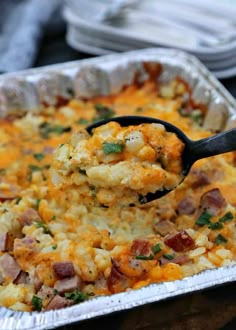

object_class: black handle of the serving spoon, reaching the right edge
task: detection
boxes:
[188,128,236,164]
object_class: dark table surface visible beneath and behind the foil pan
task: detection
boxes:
[34,25,236,330]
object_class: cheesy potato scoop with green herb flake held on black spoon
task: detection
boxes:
[52,122,184,207]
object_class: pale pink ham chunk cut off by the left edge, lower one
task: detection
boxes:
[0,253,21,281]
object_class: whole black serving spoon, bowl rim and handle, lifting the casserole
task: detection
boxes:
[86,116,236,204]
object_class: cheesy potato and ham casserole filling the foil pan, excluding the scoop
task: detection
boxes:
[0,73,236,311]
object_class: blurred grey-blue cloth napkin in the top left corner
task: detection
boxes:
[0,0,62,73]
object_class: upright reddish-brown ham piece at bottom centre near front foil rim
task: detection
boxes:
[107,260,130,293]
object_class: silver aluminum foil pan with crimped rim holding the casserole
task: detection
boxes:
[0,49,236,330]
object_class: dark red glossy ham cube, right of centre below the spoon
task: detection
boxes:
[164,230,195,252]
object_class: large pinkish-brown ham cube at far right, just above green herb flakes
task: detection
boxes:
[200,188,227,216]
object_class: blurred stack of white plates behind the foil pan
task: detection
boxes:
[64,0,236,78]
